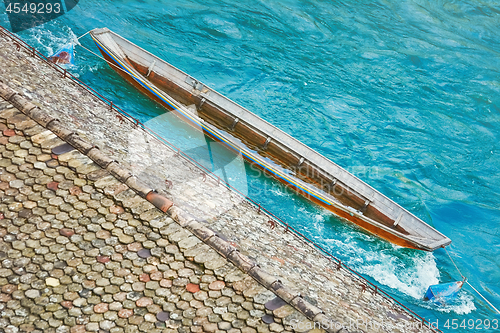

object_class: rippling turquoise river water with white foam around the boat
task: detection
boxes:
[0,0,500,332]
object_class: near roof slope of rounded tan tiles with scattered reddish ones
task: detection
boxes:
[0,103,318,332]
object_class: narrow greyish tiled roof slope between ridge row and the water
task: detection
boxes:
[0,28,430,332]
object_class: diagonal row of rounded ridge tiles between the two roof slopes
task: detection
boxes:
[0,80,348,333]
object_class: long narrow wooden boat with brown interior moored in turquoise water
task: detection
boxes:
[90,28,451,251]
